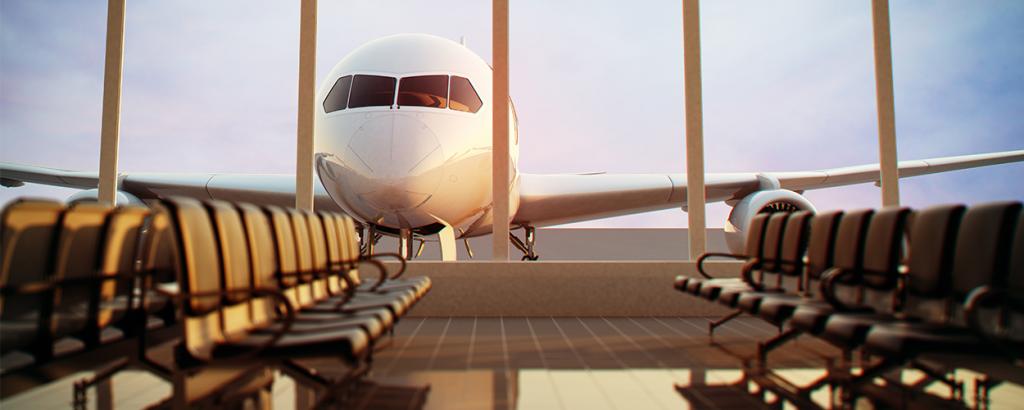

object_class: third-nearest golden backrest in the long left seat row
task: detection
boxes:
[238,204,279,325]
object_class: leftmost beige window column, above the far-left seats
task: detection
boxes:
[97,0,125,205]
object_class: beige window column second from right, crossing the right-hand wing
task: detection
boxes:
[683,0,707,260]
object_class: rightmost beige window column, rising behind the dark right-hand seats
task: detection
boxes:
[871,0,899,206]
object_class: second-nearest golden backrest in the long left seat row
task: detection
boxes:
[206,201,253,337]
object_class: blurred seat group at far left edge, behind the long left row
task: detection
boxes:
[0,200,175,396]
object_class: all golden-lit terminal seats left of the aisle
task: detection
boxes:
[0,198,430,408]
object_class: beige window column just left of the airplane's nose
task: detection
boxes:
[295,0,316,210]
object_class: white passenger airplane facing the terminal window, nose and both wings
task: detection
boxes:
[0,34,1024,260]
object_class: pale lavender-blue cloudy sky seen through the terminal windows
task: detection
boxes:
[0,0,1024,228]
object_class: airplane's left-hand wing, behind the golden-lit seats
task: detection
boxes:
[0,163,341,211]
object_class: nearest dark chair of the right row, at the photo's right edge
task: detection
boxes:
[850,203,1024,403]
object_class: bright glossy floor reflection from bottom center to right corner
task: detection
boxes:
[376,368,1024,410]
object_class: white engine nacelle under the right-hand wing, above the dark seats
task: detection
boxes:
[725,190,816,253]
